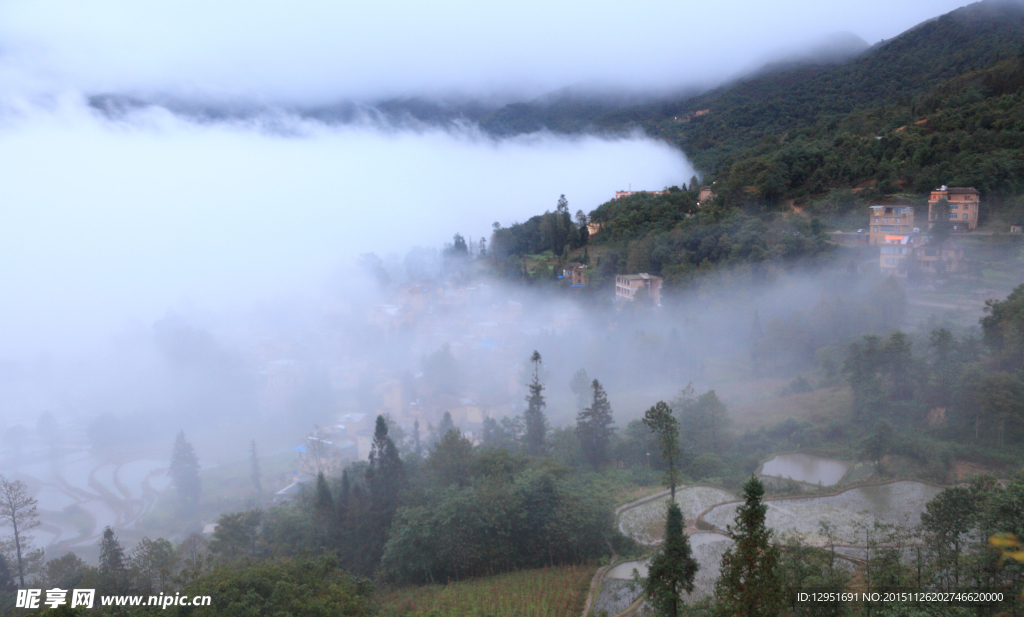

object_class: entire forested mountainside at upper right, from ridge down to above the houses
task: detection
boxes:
[471,0,1024,209]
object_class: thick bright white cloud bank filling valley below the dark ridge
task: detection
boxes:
[0,94,693,356]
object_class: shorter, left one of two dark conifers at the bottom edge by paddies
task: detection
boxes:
[643,501,700,617]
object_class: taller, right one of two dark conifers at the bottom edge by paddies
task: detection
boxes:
[715,476,785,617]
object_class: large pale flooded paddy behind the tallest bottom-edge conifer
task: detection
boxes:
[703,481,941,545]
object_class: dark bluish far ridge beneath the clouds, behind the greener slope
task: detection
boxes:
[466,0,1024,179]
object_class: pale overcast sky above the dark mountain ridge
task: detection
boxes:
[0,0,966,101]
